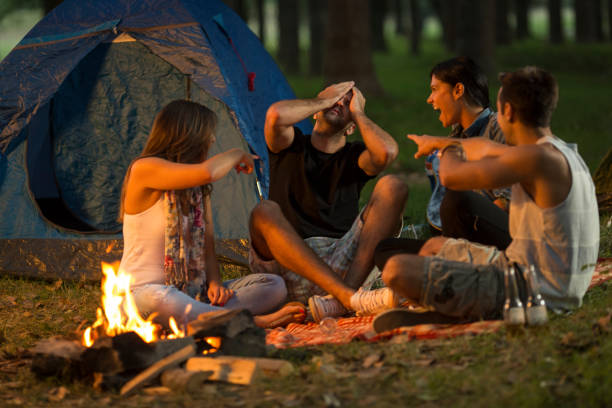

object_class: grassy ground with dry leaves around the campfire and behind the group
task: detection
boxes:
[0,11,612,407]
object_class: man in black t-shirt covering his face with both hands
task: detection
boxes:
[250,81,408,321]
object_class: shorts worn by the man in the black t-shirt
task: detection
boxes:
[249,214,363,304]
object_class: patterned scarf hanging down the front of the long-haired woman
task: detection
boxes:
[164,187,206,296]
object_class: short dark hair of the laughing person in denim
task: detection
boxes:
[429,57,489,108]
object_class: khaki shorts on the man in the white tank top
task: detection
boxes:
[420,238,525,320]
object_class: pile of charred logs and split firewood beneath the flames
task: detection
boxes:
[30,310,293,395]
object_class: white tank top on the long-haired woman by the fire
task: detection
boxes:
[119,198,166,287]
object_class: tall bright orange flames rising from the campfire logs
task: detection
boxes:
[82,262,185,347]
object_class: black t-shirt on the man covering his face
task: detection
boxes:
[268,127,374,238]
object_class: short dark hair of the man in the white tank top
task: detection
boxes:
[499,66,559,127]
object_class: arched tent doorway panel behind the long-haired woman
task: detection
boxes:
[27,41,256,238]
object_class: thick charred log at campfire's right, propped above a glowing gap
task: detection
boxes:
[187,310,266,357]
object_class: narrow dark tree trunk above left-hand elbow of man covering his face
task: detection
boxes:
[278,0,300,74]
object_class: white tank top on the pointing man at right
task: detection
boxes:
[506,137,599,310]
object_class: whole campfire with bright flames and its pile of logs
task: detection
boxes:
[26,263,290,395]
